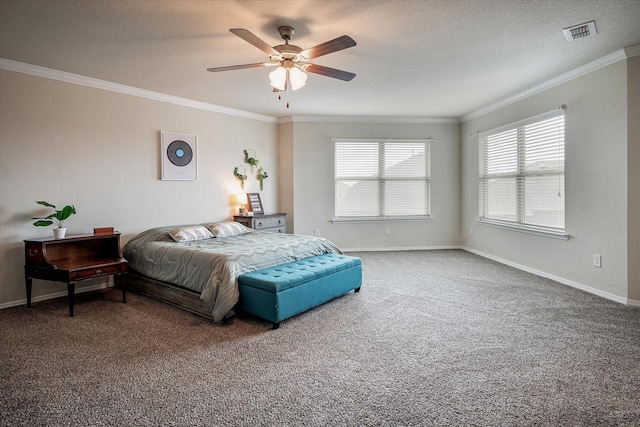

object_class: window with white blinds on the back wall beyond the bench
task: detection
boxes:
[334,138,430,219]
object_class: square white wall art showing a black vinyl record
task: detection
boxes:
[160,131,198,181]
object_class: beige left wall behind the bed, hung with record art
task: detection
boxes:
[0,70,279,307]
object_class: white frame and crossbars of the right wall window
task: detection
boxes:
[477,110,569,239]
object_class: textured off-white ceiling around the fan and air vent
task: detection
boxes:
[0,0,640,118]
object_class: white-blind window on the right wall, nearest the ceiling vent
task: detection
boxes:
[479,111,565,232]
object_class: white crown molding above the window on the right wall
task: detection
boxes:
[460,46,628,123]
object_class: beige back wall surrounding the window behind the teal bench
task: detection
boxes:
[289,119,460,250]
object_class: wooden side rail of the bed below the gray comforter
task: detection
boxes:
[127,269,213,320]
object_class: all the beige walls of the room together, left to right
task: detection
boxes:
[0,51,640,308]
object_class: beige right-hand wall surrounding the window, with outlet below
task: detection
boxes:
[462,61,637,301]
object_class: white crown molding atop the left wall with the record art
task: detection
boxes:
[0,58,277,123]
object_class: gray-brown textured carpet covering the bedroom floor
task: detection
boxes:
[0,251,640,426]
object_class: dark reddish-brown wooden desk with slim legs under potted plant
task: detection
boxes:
[24,233,127,316]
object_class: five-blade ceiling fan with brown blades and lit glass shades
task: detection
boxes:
[207,26,356,97]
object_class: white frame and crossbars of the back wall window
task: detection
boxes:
[331,137,435,223]
